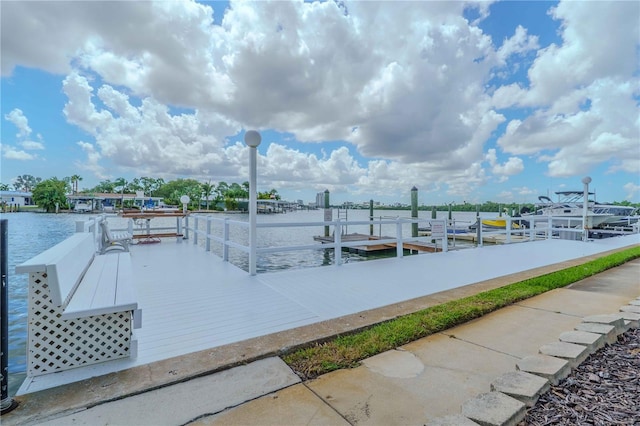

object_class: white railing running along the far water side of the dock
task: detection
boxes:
[82,214,636,276]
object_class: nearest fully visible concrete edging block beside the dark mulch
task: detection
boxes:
[462,392,526,426]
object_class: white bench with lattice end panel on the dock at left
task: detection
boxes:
[16,233,142,377]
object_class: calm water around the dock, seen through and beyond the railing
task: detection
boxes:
[2,210,495,395]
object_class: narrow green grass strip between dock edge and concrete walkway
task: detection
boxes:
[280,247,640,380]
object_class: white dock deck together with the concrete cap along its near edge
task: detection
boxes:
[3,234,640,424]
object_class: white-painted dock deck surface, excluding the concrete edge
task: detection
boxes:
[18,234,640,394]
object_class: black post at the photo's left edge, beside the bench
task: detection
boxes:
[0,219,18,414]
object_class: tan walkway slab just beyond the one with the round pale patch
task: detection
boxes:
[444,302,582,358]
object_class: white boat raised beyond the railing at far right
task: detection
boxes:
[521,191,614,229]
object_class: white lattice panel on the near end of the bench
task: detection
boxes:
[27,272,132,377]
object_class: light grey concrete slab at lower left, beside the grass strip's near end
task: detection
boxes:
[39,358,300,426]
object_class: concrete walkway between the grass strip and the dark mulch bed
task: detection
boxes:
[12,259,640,425]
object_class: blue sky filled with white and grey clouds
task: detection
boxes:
[0,0,640,205]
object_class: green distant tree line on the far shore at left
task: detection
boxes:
[0,175,280,212]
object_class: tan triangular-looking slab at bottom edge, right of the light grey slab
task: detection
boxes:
[194,384,349,426]
